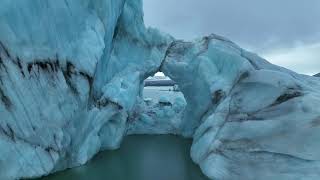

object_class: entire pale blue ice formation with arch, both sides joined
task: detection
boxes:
[0,0,320,180]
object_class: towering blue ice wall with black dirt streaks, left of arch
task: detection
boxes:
[0,0,172,179]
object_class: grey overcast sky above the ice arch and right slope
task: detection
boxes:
[144,0,320,74]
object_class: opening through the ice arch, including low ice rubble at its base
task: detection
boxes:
[128,72,187,134]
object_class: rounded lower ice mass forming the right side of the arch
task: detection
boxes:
[162,35,320,180]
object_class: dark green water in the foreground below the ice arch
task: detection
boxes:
[41,135,207,180]
